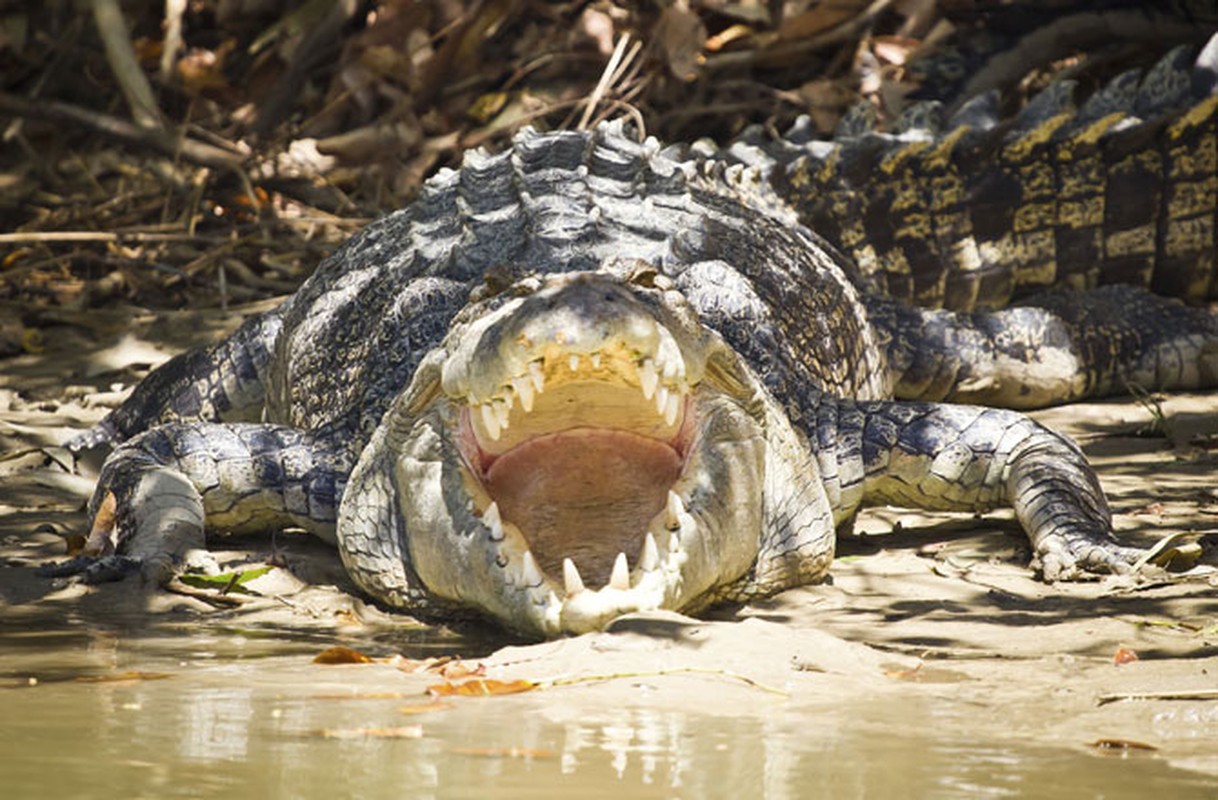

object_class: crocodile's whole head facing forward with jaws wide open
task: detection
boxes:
[340,263,832,636]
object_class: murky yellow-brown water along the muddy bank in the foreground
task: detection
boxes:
[0,620,1218,799]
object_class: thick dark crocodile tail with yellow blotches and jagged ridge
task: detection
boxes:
[774,37,1218,311]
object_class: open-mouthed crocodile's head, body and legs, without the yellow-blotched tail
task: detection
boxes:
[58,37,1218,637]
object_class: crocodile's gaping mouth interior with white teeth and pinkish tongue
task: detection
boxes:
[458,343,695,603]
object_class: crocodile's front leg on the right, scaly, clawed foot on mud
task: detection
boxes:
[816,397,1141,581]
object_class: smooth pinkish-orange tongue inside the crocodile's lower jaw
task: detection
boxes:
[486,427,681,588]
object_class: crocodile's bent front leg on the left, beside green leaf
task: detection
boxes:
[52,423,350,583]
